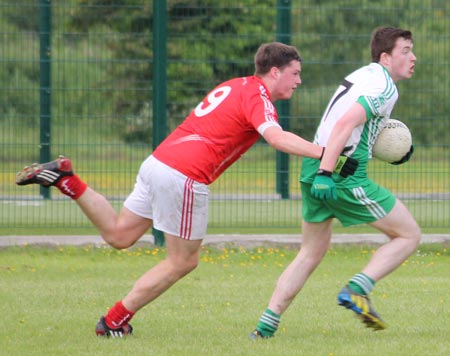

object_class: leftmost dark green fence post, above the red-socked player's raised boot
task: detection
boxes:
[39,0,52,199]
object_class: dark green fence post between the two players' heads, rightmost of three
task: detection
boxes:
[276,0,291,199]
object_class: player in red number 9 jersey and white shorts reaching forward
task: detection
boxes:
[16,42,357,337]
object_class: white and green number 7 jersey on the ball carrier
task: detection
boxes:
[300,63,398,188]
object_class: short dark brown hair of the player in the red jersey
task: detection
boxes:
[255,42,302,75]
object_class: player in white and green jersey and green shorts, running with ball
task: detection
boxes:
[250,27,421,338]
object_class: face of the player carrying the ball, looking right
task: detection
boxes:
[389,37,416,82]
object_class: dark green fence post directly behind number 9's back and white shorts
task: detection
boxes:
[152,0,167,246]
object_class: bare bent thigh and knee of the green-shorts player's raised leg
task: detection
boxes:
[370,199,421,239]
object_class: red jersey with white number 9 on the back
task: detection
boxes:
[153,76,280,184]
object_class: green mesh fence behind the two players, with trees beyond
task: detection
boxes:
[0,0,450,235]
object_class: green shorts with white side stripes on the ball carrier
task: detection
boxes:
[301,180,396,226]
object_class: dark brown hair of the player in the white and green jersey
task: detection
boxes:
[370,27,412,62]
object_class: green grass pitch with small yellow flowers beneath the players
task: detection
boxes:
[0,244,450,356]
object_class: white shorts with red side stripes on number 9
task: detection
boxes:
[124,156,209,240]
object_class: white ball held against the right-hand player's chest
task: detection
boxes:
[372,119,412,163]
